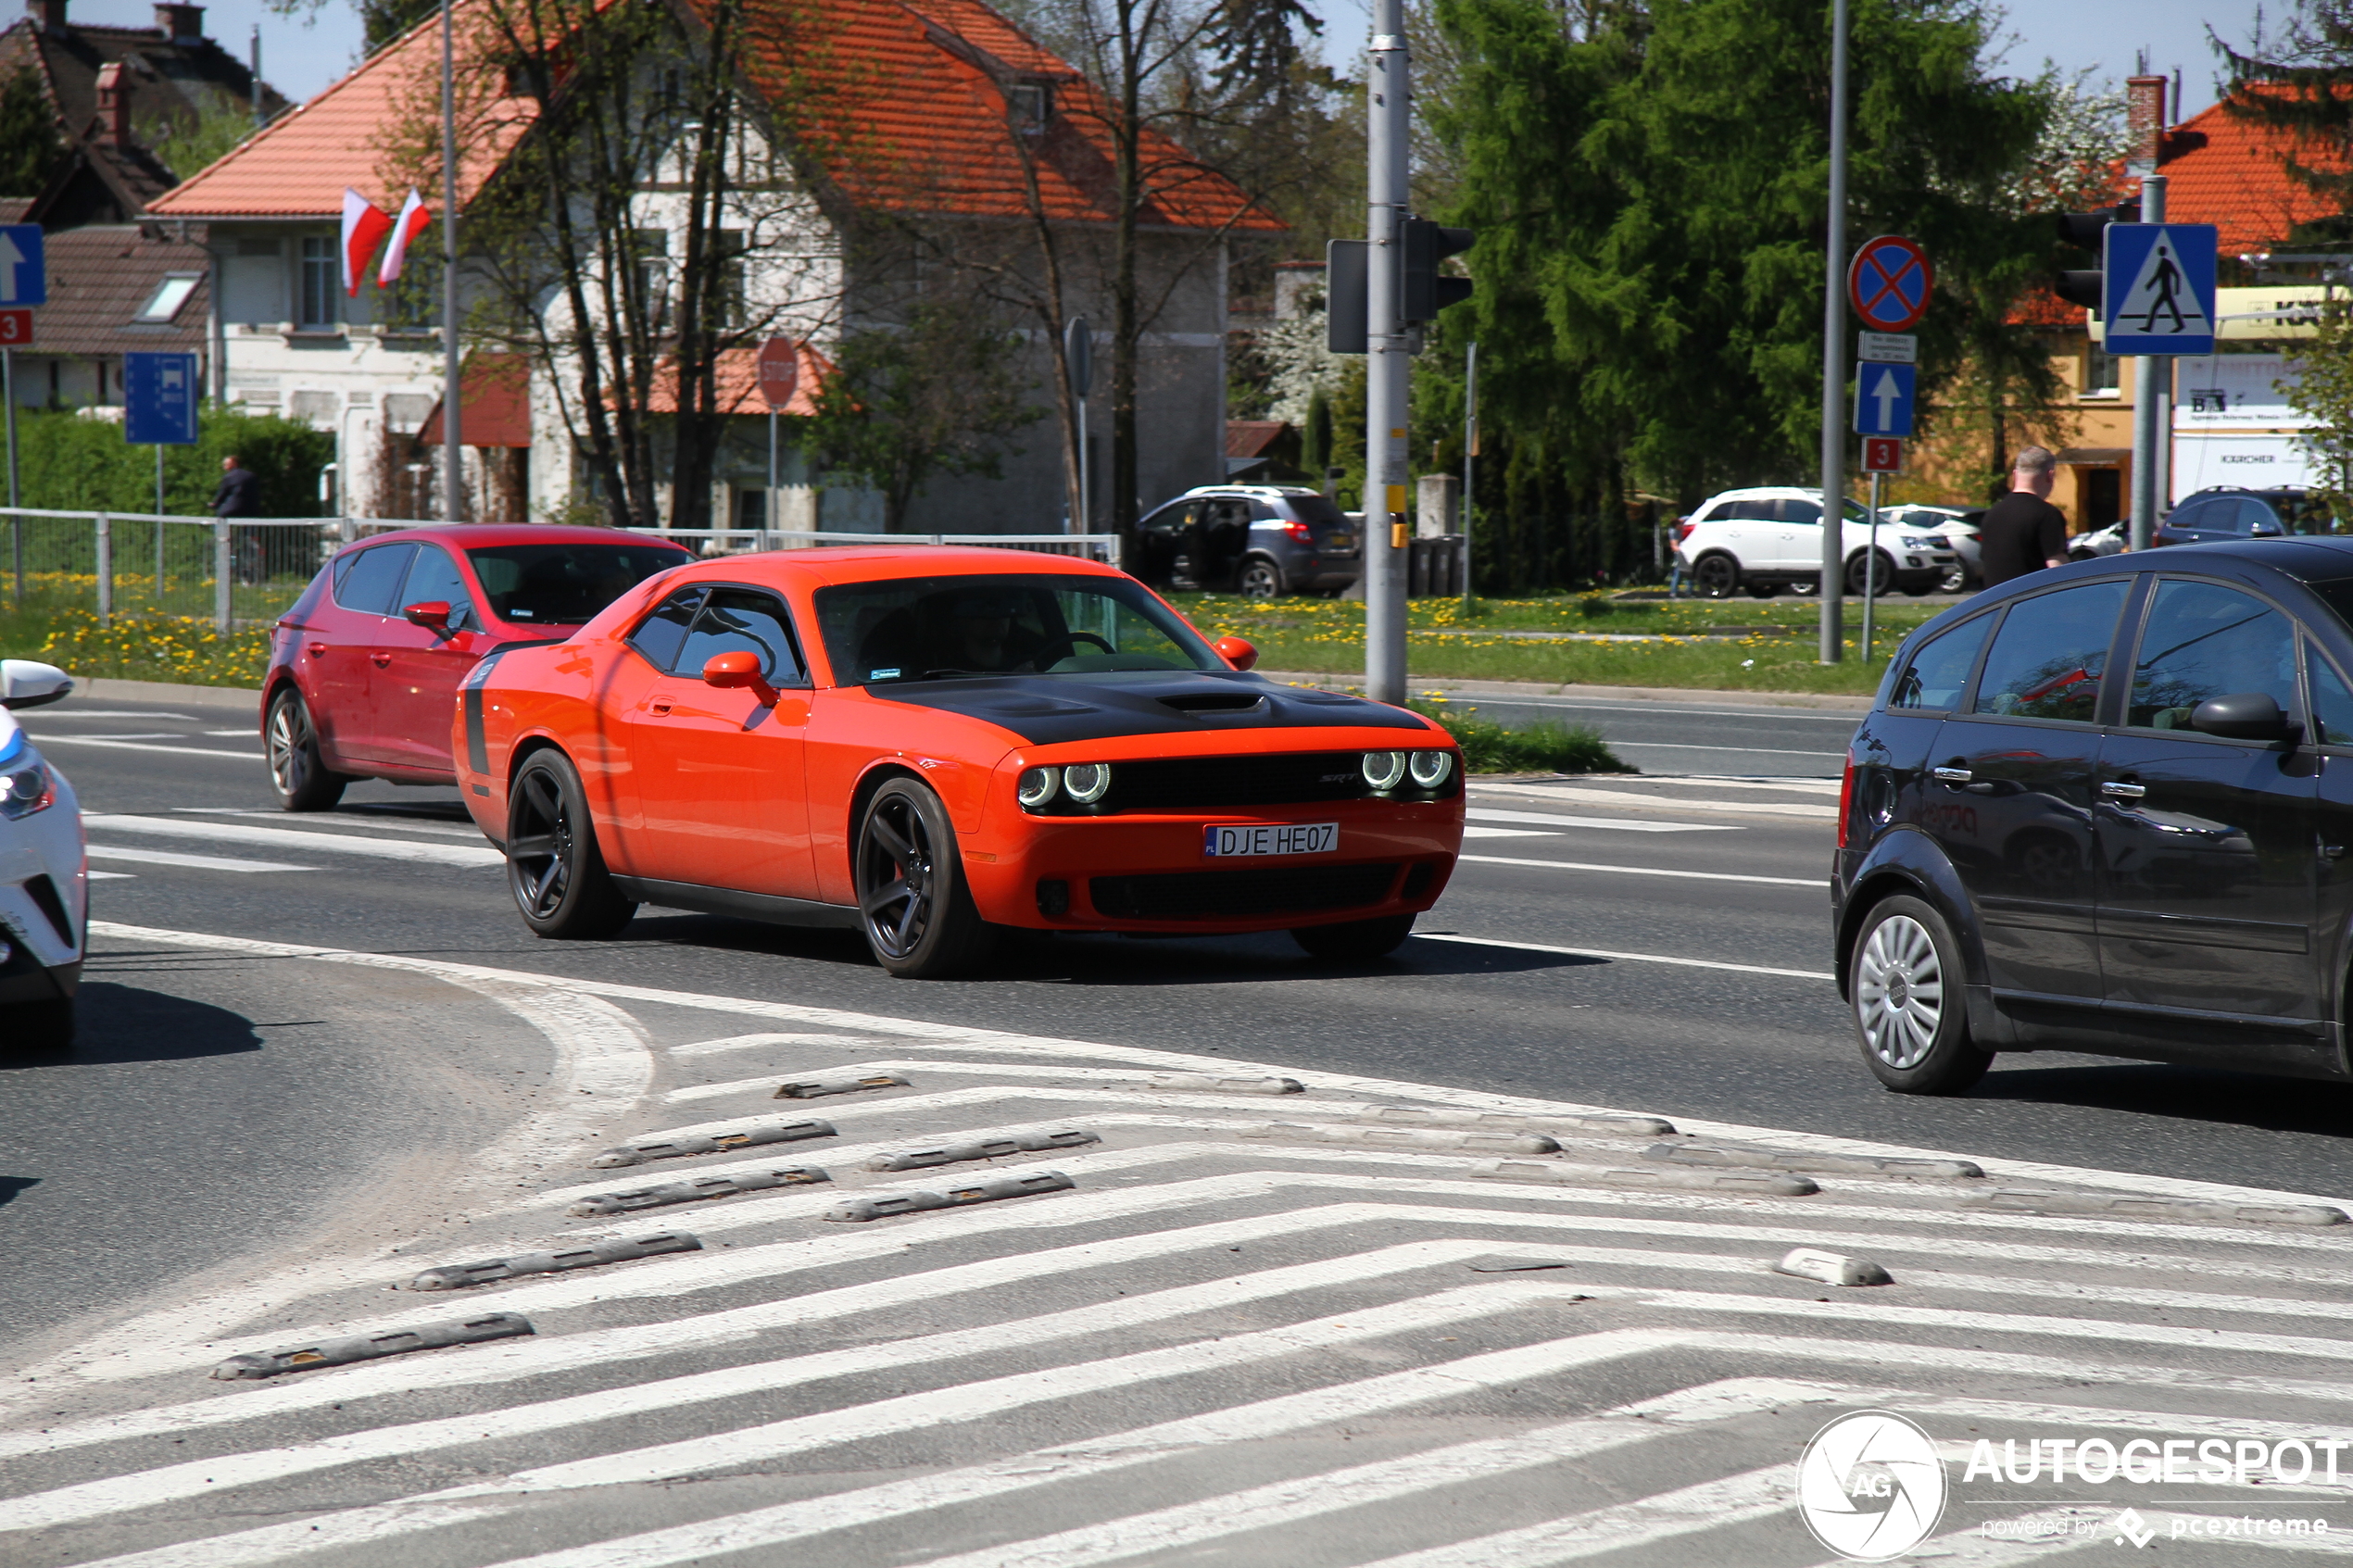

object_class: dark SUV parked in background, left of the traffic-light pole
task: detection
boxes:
[1129,484,1363,599]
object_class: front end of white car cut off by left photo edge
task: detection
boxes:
[0,659,90,1051]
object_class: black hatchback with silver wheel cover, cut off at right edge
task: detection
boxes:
[1831,538,2353,1093]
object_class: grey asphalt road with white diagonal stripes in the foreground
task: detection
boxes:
[0,698,2353,1568]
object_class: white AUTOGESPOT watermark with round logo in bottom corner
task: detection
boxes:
[1798,1411,2353,1563]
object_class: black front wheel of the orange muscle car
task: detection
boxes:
[851,778,995,980]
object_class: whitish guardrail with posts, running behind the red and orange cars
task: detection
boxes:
[0,506,1120,633]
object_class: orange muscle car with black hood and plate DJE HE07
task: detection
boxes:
[452,546,1464,978]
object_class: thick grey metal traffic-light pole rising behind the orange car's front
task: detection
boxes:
[1363,0,1415,703]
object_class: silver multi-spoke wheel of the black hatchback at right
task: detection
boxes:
[1847,894,1993,1096]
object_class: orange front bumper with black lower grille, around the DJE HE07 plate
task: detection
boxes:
[964,799,1461,935]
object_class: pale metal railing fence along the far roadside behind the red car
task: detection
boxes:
[0,506,1120,633]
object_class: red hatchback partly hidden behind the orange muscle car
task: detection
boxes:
[261,524,694,811]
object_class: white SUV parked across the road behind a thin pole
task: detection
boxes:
[1675,484,1960,599]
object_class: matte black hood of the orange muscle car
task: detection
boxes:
[866,670,1428,746]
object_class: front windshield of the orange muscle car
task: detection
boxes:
[816,576,1228,686]
